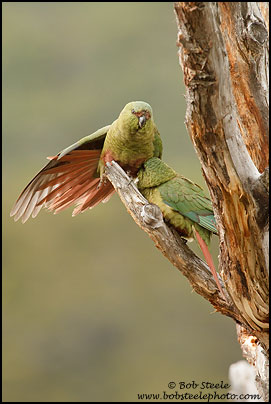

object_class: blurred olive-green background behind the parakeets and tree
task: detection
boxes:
[3,2,241,402]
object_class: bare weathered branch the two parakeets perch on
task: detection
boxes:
[106,161,249,322]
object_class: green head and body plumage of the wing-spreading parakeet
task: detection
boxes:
[58,101,163,176]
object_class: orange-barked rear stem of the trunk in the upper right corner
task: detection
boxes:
[221,2,269,172]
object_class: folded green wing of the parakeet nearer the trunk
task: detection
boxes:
[159,176,217,234]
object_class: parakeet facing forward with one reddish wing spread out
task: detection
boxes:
[10,101,162,223]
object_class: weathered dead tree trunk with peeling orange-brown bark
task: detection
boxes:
[175,2,269,400]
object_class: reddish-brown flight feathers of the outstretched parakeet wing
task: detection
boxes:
[10,150,114,223]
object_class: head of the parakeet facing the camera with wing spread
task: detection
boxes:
[119,101,154,133]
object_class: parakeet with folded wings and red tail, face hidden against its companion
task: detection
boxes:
[137,157,225,298]
